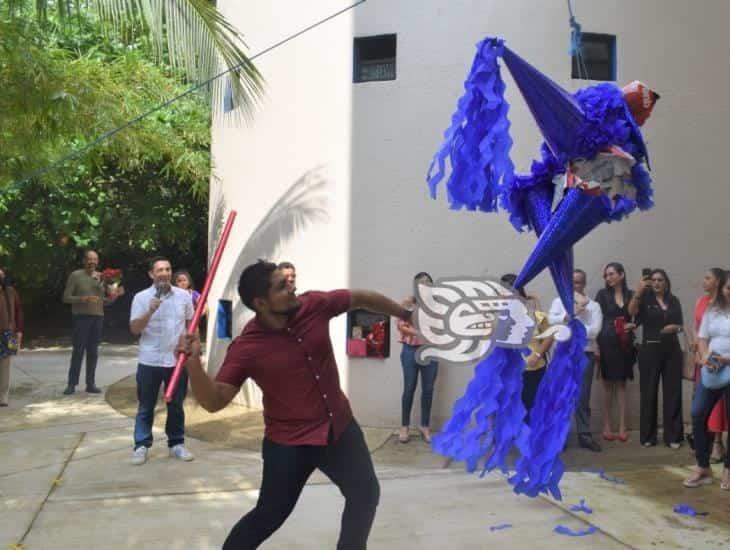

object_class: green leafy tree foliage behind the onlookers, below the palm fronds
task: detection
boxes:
[0,14,210,314]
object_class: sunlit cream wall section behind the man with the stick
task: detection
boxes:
[208,0,352,405]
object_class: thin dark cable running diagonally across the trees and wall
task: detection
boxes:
[15,0,366,187]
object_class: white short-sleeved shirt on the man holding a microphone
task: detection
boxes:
[129,285,193,367]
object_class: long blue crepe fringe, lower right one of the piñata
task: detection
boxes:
[510,319,587,500]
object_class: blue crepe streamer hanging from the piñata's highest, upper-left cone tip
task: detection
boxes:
[427,38,514,212]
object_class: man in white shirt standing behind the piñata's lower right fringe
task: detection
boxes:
[548,269,603,453]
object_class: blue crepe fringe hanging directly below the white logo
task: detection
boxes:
[433,348,529,475]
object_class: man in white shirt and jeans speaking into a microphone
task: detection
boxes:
[129,257,193,465]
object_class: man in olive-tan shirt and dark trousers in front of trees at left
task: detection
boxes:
[63,250,124,395]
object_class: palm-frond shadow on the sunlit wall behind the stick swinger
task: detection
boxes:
[208,166,332,408]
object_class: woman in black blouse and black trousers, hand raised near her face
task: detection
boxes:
[629,269,684,449]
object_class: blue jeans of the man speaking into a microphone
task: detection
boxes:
[134,363,188,449]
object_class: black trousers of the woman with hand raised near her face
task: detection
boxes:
[639,341,684,445]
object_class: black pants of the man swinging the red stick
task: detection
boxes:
[223,420,380,550]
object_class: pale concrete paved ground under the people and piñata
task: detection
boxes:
[0,347,730,550]
